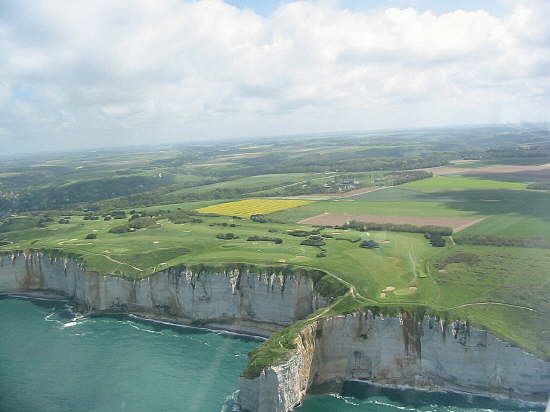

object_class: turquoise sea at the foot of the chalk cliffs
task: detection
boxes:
[0,299,544,412]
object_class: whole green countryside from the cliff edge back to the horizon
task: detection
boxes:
[0,124,550,357]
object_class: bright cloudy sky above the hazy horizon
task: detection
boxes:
[0,0,550,154]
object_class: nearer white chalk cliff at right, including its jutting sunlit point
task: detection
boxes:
[240,312,550,412]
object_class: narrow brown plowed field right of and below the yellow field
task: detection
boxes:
[298,213,483,232]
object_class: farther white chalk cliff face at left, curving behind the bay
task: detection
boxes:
[0,253,328,334]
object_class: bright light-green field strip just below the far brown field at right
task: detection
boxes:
[401,176,527,190]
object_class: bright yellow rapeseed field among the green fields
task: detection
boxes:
[197,199,312,217]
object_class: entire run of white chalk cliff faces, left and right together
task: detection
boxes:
[0,252,550,412]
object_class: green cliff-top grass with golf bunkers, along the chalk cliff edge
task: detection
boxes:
[0,206,550,366]
